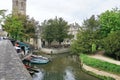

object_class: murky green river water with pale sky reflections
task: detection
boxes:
[32,54,99,80]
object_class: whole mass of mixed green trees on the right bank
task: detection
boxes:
[71,8,120,59]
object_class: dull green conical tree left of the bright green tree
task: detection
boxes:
[71,15,99,53]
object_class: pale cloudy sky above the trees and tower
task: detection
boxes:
[0,0,120,25]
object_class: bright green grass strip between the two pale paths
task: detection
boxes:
[80,54,120,74]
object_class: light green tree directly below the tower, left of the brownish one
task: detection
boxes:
[4,15,23,40]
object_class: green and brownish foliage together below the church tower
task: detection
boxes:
[4,14,38,40]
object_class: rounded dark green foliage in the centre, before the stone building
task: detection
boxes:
[42,17,68,44]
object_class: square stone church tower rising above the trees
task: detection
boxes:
[12,0,26,15]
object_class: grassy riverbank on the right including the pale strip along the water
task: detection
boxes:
[80,54,120,80]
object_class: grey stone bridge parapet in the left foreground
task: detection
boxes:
[0,40,32,80]
